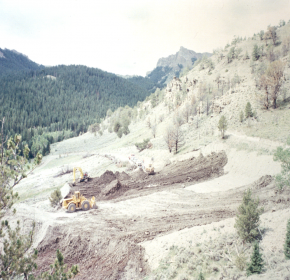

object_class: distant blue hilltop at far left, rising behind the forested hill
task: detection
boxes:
[0,49,44,76]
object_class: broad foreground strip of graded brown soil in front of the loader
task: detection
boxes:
[34,171,290,280]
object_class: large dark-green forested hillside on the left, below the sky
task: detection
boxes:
[0,66,148,156]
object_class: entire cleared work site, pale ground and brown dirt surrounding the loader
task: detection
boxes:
[11,128,289,279]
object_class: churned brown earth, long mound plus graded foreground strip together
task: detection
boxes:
[23,152,289,279]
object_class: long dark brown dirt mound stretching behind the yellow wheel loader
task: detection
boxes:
[66,151,227,201]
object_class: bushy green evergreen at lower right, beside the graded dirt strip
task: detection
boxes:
[235,189,263,242]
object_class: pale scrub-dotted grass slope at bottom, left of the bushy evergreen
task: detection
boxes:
[144,233,278,280]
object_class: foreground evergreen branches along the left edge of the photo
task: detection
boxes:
[0,122,42,280]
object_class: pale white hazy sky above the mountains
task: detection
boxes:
[0,0,290,76]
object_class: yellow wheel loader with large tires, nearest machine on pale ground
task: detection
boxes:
[62,191,97,213]
